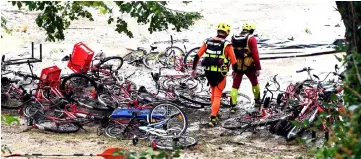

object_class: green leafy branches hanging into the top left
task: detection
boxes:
[6,1,202,41]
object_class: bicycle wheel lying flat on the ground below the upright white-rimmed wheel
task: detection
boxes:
[152,135,198,150]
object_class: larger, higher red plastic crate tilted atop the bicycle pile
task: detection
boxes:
[68,42,94,72]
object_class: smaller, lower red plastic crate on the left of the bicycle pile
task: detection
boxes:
[40,66,61,88]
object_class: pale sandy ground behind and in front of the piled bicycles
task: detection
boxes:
[1,1,344,158]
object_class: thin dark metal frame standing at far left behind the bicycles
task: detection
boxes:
[2,42,43,65]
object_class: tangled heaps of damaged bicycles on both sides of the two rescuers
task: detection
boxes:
[1,43,344,149]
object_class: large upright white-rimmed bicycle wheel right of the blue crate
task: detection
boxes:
[148,102,188,136]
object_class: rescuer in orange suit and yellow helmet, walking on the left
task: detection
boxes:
[192,23,236,127]
